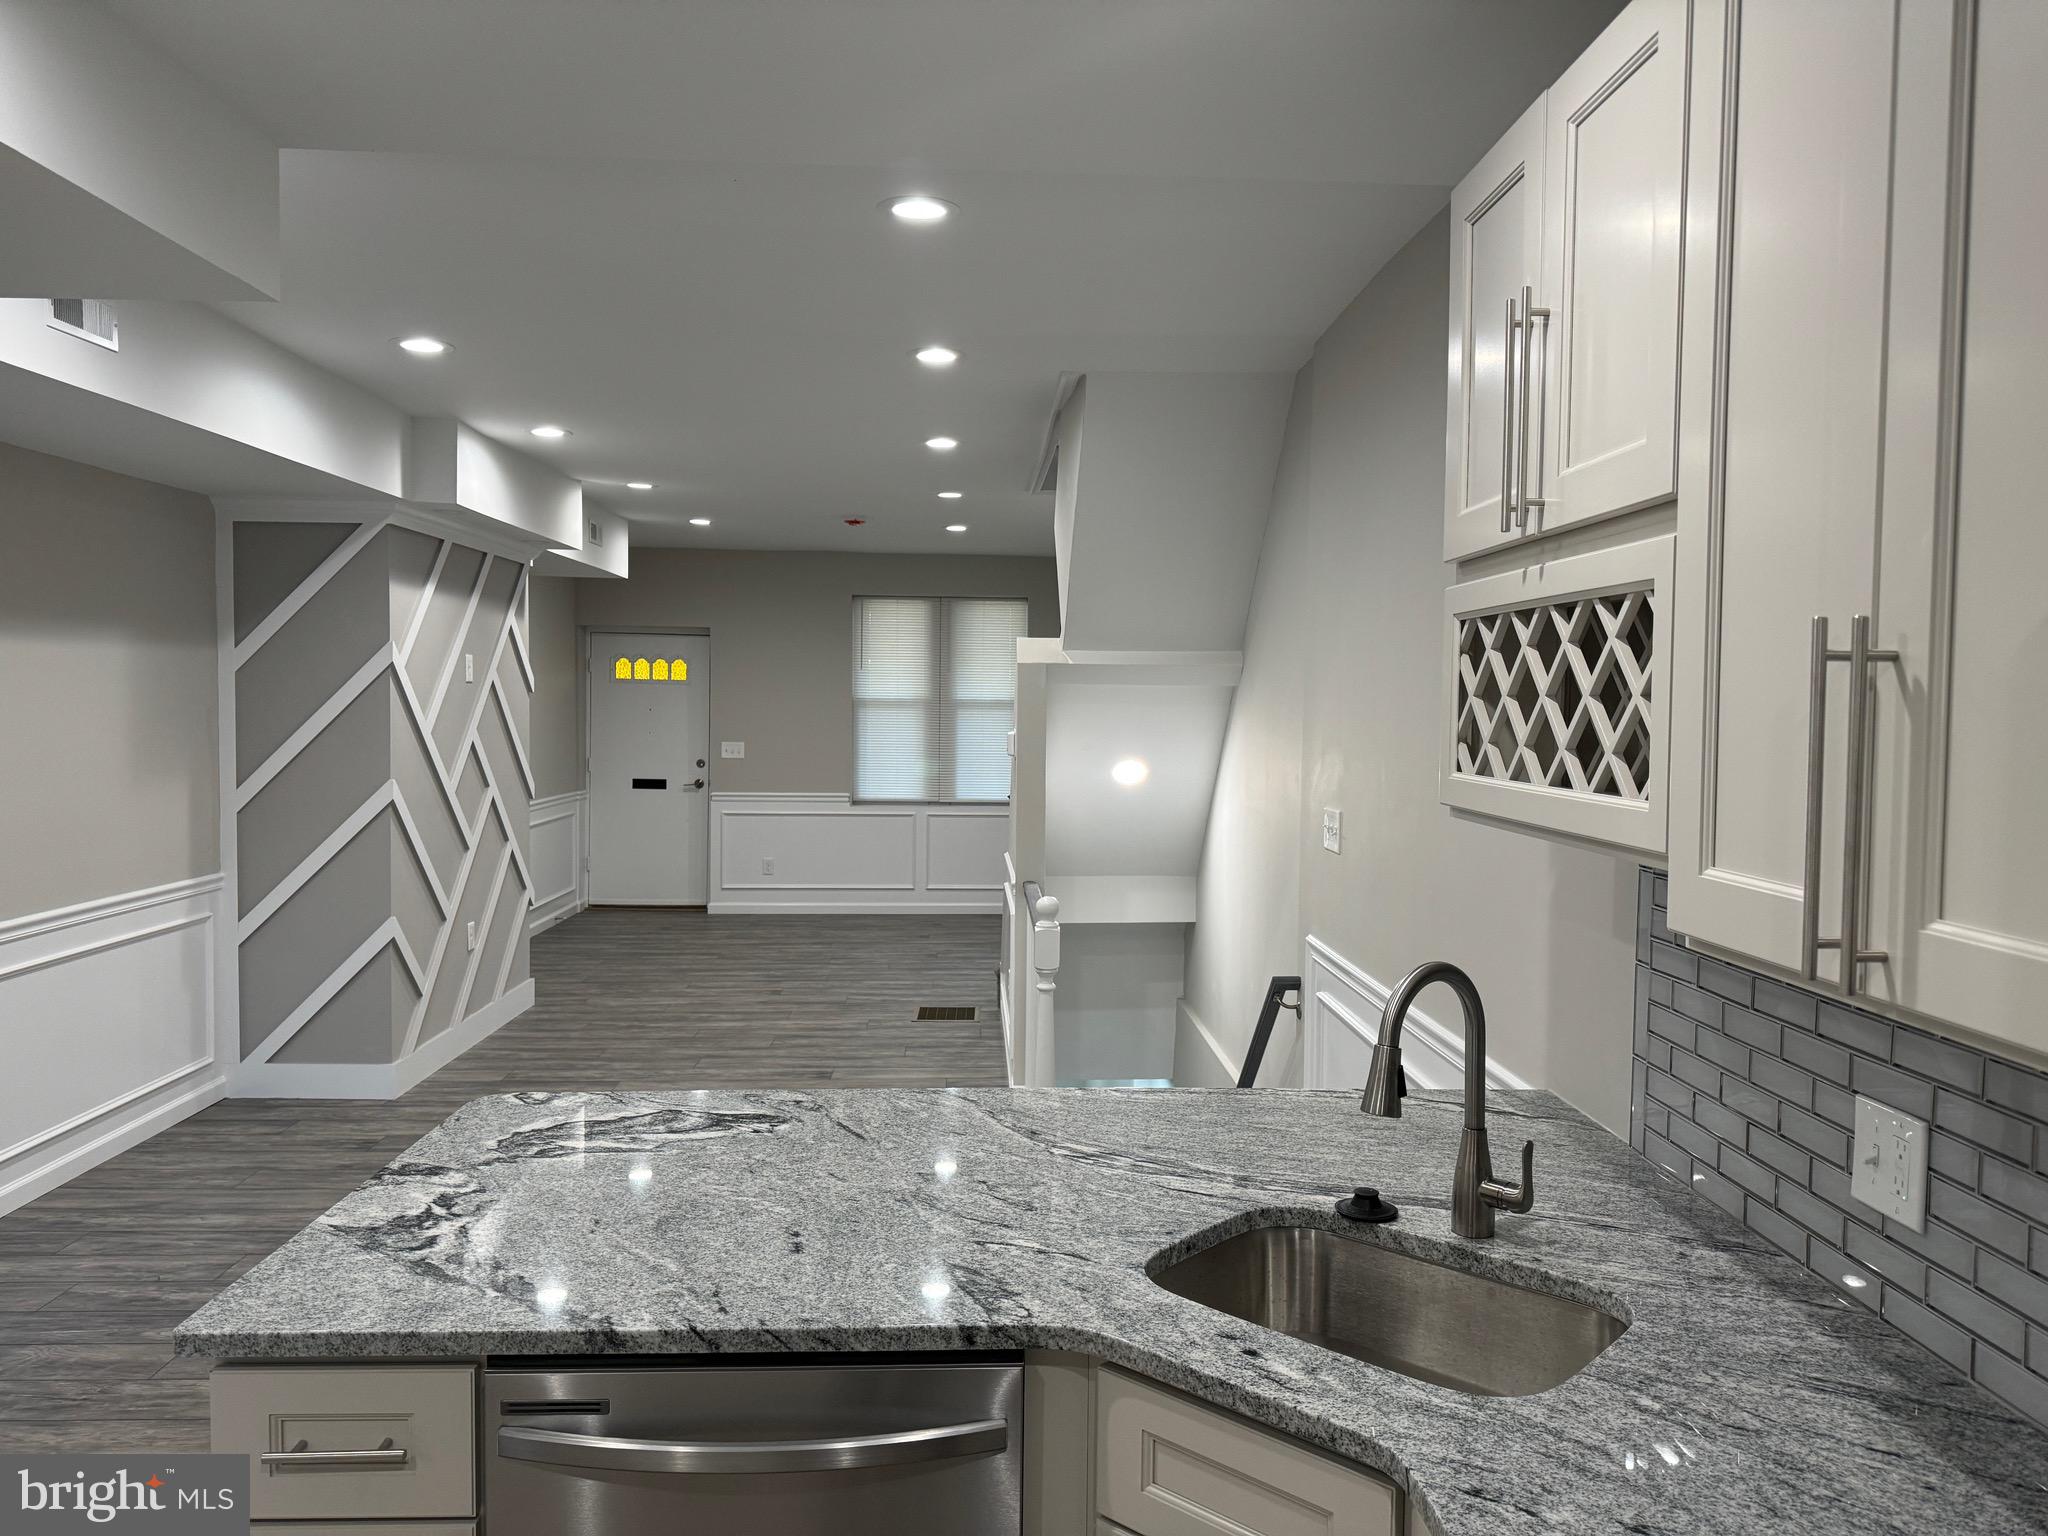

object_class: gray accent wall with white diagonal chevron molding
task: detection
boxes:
[223,514,535,1098]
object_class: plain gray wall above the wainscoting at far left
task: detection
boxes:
[0,444,221,920]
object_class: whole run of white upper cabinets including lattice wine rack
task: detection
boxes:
[1442,0,2048,1059]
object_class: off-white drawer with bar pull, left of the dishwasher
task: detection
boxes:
[211,1366,477,1536]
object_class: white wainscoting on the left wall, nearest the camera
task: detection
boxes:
[0,874,227,1212]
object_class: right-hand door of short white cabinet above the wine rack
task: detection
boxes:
[1518,0,1688,532]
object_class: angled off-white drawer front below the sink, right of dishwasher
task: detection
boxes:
[1096,1368,1401,1536]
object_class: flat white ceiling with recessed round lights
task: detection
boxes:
[102,0,1616,553]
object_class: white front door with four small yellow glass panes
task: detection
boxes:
[590,631,711,907]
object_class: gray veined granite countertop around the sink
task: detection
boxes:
[176,1090,2048,1536]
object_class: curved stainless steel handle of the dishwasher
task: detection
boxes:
[498,1419,1010,1475]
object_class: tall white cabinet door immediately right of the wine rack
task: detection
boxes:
[1671,0,1894,979]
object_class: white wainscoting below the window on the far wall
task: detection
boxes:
[711,795,1010,913]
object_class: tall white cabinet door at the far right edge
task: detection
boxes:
[1862,0,2048,1051]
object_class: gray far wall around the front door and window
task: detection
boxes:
[573,549,1059,793]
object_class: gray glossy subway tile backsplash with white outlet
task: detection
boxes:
[1630,870,2048,1427]
